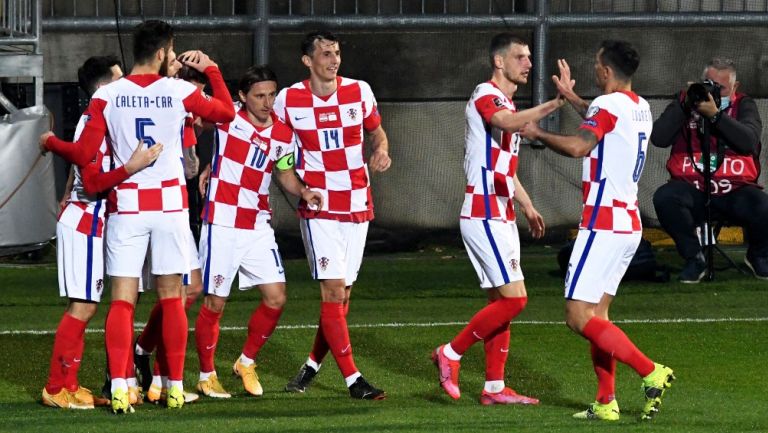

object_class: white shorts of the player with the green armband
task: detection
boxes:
[200,223,285,298]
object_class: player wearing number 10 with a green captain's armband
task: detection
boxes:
[195,66,323,398]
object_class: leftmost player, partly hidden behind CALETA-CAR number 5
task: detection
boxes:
[41,56,162,409]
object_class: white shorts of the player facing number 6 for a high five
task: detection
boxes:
[459,219,524,289]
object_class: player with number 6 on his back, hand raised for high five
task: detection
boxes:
[520,40,675,421]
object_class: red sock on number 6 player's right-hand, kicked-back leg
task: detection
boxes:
[581,317,654,377]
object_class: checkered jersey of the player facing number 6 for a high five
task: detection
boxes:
[461,81,520,222]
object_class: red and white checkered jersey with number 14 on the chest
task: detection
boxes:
[274,77,381,222]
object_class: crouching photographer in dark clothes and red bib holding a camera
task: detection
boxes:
[651,58,768,283]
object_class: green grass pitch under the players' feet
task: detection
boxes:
[0,246,768,433]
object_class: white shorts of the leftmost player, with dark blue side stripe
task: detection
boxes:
[56,223,104,302]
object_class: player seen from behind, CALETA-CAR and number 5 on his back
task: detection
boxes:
[39,20,234,413]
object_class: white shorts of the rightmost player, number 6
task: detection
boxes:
[565,230,642,304]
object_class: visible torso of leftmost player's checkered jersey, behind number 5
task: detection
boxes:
[59,112,111,237]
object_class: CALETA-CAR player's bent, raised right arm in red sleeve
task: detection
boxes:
[179,51,235,123]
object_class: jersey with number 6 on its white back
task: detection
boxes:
[579,91,653,233]
